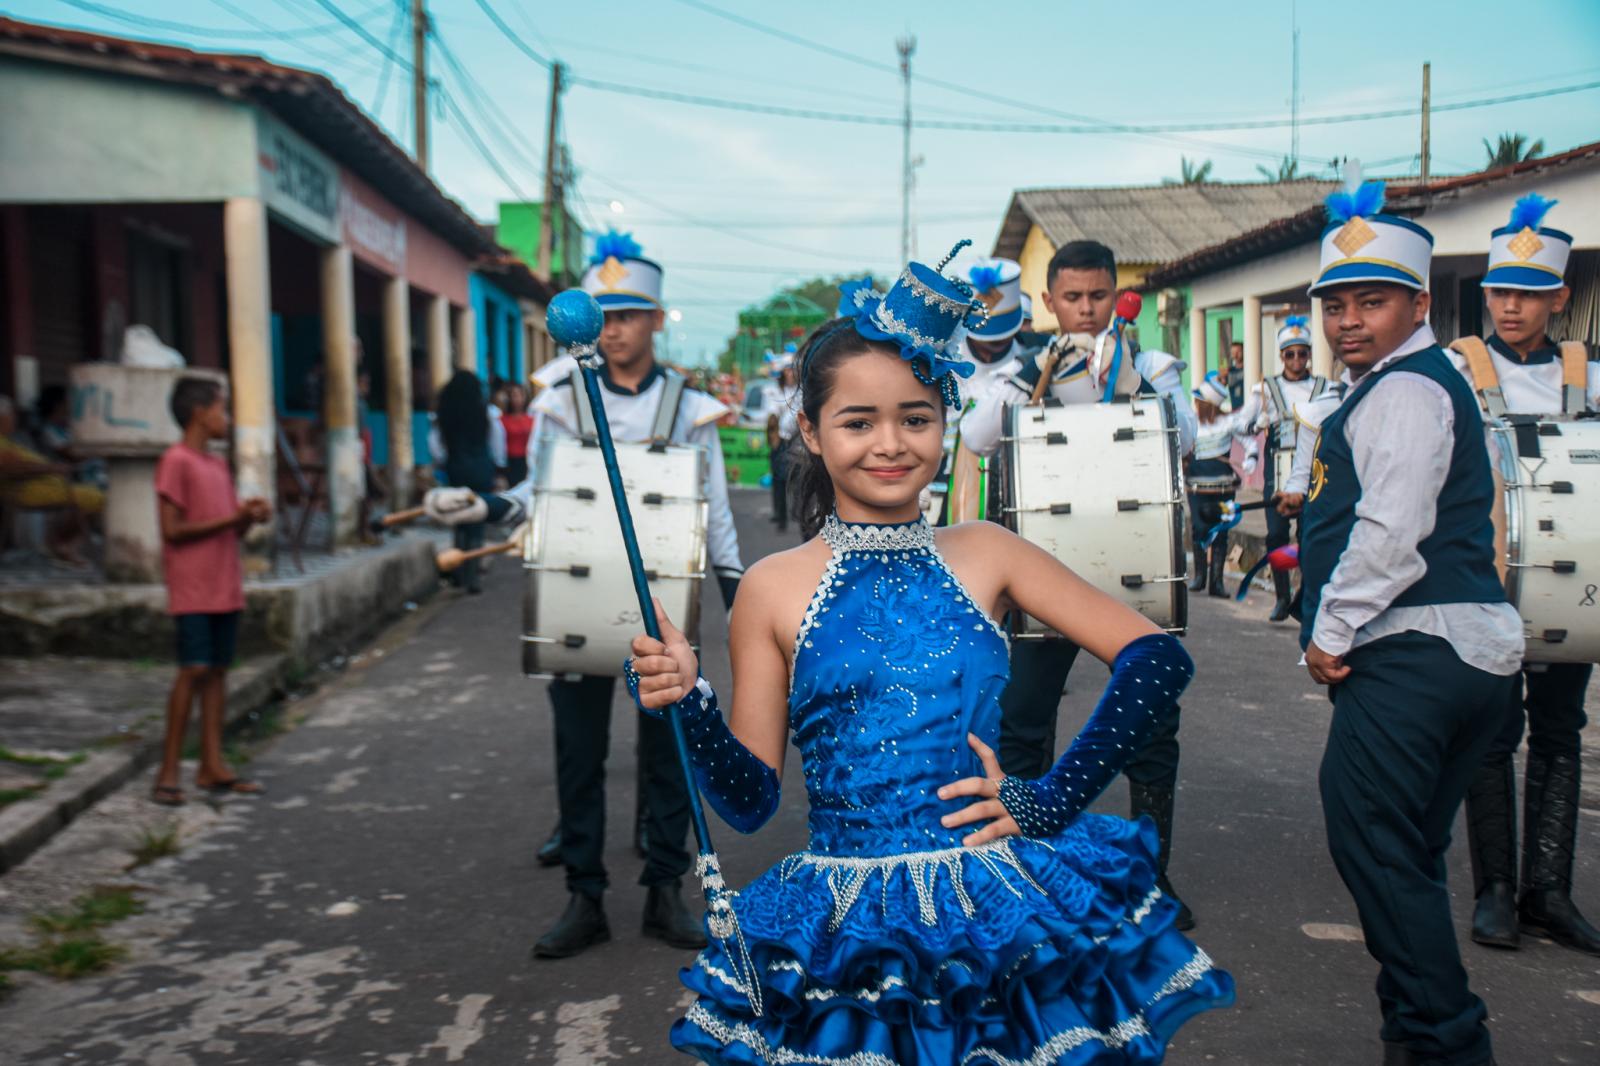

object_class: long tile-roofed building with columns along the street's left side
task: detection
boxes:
[0,18,550,563]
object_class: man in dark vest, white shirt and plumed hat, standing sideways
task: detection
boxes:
[1299,181,1522,1066]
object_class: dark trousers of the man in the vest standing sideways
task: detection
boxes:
[1318,632,1517,1066]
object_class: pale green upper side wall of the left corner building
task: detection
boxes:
[0,56,258,203]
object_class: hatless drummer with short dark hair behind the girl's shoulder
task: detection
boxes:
[960,240,1195,930]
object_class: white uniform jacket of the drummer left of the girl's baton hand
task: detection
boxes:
[501,362,744,576]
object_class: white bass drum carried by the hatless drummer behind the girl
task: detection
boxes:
[1002,395,1189,637]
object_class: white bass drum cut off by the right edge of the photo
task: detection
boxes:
[1488,415,1600,663]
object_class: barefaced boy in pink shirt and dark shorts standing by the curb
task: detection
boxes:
[152,378,272,807]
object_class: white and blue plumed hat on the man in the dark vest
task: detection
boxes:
[1307,160,1434,296]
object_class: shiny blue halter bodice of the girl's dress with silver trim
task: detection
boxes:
[789,517,1008,856]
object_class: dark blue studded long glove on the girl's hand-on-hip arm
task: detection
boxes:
[1000,632,1195,837]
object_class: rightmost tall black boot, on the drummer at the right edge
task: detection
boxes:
[1517,751,1600,956]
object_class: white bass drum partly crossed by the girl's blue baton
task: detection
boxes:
[522,437,707,677]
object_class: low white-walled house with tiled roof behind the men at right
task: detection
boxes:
[1142,142,1600,398]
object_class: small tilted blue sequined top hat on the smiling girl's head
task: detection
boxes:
[838,240,989,408]
